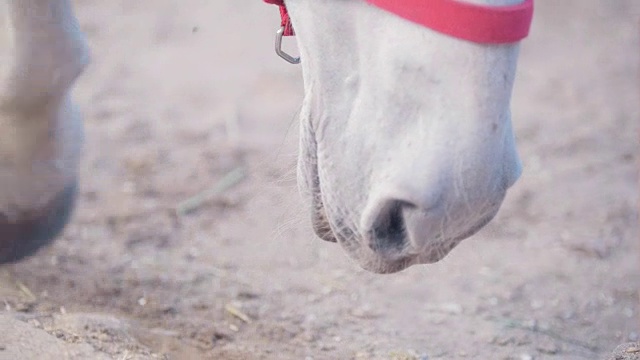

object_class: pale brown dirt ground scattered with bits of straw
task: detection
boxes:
[0,0,640,360]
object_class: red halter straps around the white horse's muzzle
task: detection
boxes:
[264,0,533,44]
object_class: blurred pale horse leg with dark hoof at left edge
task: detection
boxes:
[0,0,89,264]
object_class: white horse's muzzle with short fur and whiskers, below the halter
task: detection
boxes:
[287,0,521,273]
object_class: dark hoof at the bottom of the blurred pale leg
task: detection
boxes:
[0,182,77,264]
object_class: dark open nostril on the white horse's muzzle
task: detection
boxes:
[369,200,415,252]
